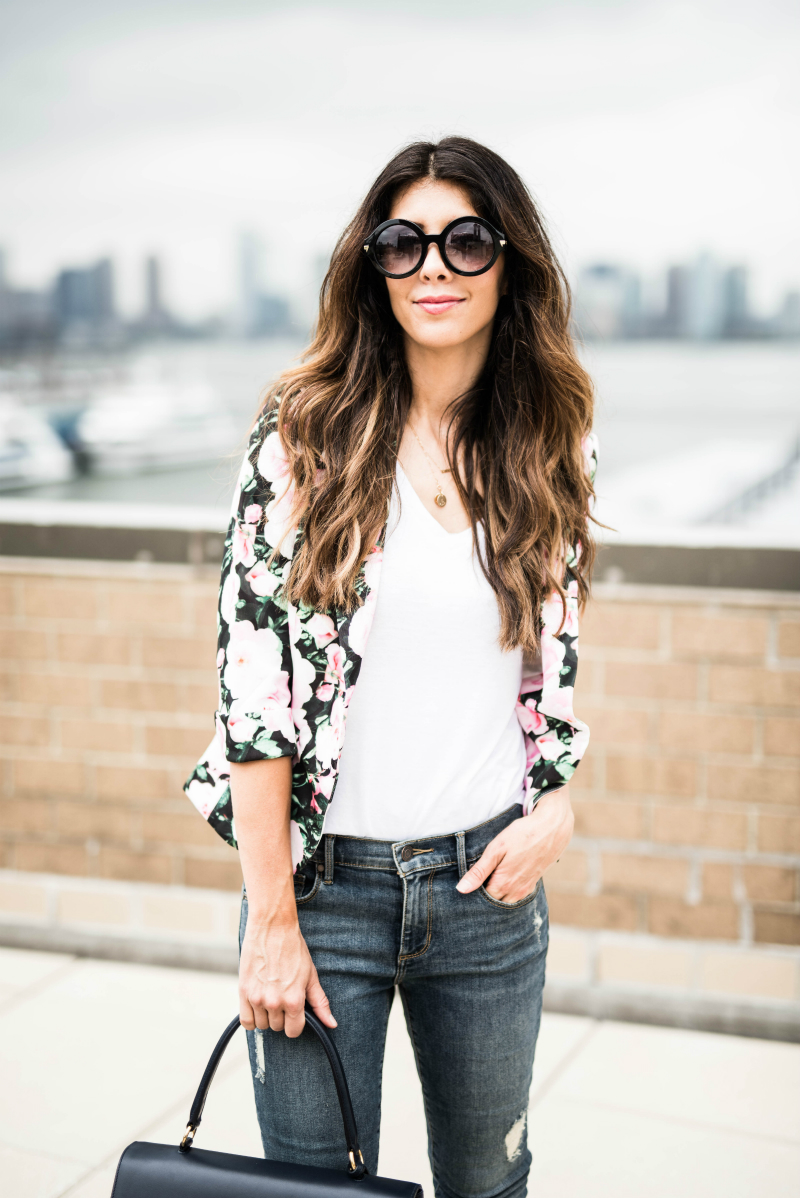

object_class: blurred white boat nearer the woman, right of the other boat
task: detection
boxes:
[75,383,241,474]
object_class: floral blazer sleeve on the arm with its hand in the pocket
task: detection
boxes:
[517,434,598,815]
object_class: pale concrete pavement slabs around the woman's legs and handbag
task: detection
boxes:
[0,949,800,1198]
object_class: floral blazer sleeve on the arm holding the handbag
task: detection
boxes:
[217,412,297,762]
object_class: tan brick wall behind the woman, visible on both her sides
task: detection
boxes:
[0,558,800,946]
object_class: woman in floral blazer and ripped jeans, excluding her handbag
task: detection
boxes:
[187,138,594,1198]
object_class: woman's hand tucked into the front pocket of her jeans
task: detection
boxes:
[456,786,575,903]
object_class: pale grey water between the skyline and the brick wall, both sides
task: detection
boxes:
[0,340,800,538]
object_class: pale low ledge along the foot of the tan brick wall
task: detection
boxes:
[0,870,800,1042]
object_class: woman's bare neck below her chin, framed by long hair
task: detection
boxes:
[406,328,491,440]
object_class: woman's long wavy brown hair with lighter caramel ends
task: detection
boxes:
[265,137,595,652]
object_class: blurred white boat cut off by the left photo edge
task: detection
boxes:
[0,394,75,491]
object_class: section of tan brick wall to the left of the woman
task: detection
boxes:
[0,558,231,889]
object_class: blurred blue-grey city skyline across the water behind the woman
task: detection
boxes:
[0,230,800,349]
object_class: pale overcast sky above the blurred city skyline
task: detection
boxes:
[0,0,800,316]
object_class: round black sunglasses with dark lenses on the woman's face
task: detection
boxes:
[364,217,505,279]
